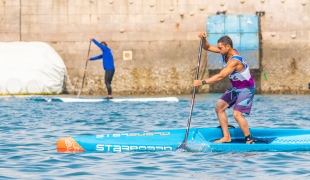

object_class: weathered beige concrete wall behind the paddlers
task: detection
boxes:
[0,0,310,95]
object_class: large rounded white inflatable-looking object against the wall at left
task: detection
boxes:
[0,42,66,95]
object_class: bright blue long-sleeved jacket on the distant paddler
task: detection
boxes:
[89,39,115,70]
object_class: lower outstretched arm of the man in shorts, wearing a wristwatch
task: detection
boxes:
[194,60,238,86]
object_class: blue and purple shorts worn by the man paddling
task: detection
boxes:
[221,86,255,114]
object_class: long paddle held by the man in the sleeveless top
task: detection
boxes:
[177,38,203,150]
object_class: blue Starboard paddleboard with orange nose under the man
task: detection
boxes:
[57,128,310,152]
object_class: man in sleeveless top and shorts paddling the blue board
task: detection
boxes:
[194,32,255,144]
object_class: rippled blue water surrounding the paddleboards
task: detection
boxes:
[0,94,310,180]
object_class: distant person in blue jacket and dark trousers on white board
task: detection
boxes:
[87,38,115,99]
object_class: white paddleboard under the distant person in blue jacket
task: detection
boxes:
[29,97,179,103]
